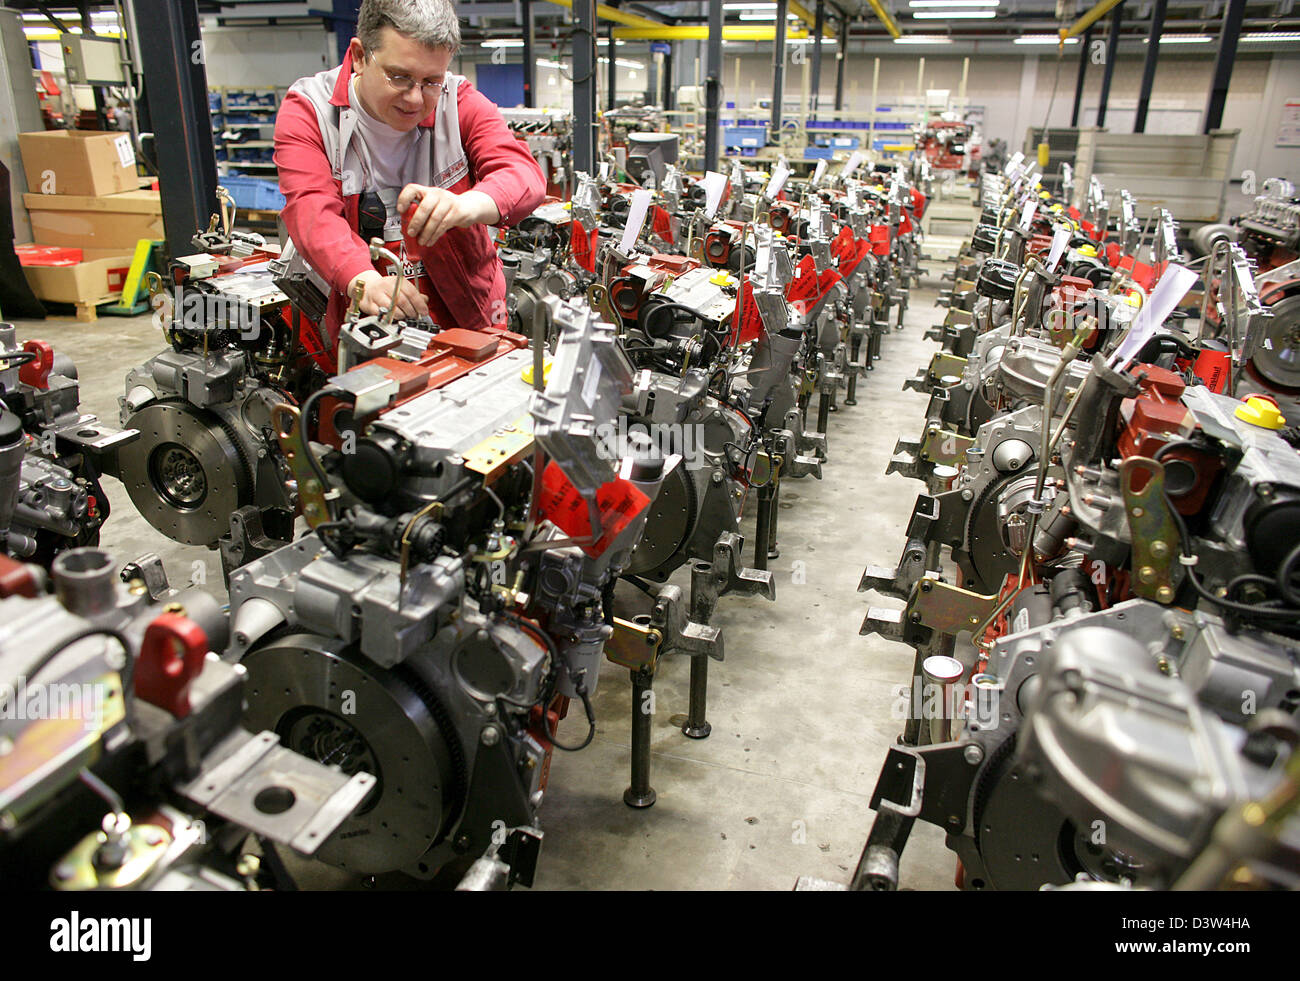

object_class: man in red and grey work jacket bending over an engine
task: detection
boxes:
[276,0,546,342]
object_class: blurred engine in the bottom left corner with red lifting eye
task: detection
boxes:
[0,548,374,891]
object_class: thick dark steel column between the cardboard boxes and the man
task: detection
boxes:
[131,0,217,262]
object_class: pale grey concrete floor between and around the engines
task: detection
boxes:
[17,274,954,890]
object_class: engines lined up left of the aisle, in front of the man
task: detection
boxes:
[0,151,926,889]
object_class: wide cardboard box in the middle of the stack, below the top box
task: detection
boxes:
[22,191,166,252]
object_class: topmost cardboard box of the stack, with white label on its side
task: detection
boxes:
[18,130,139,195]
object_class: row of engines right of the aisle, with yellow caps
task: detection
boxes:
[853,159,1300,890]
